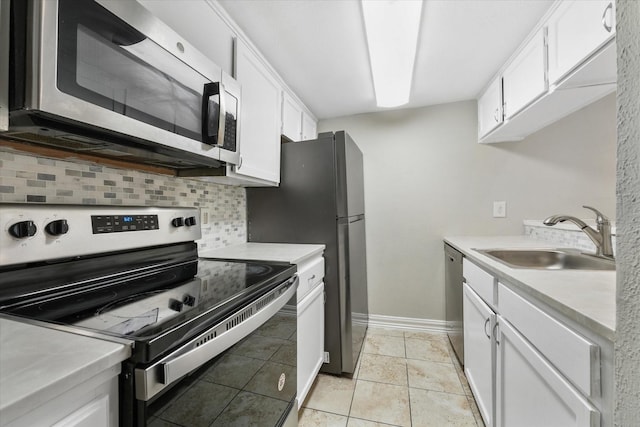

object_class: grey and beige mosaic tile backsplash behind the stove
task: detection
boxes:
[0,149,247,250]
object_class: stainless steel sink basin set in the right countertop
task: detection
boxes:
[477,249,616,270]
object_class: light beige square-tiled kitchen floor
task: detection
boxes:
[298,328,484,427]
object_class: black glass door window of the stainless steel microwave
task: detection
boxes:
[57,0,218,142]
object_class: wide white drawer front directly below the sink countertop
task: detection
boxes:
[498,283,600,397]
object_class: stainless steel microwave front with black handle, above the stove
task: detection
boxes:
[16,0,239,164]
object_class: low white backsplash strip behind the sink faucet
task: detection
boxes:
[524,220,616,254]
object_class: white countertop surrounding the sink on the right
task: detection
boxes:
[444,236,616,340]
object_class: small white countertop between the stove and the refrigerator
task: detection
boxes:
[198,242,325,264]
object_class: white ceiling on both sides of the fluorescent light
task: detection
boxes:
[219,0,553,119]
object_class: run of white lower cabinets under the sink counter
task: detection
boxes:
[463,259,613,427]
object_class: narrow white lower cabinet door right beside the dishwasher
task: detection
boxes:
[462,283,498,426]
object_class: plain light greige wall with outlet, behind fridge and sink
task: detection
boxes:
[319,95,616,320]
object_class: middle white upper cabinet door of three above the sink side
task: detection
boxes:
[502,28,547,120]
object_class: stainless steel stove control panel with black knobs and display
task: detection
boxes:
[0,203,202,267]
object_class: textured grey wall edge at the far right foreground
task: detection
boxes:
[614,0,640,426]
